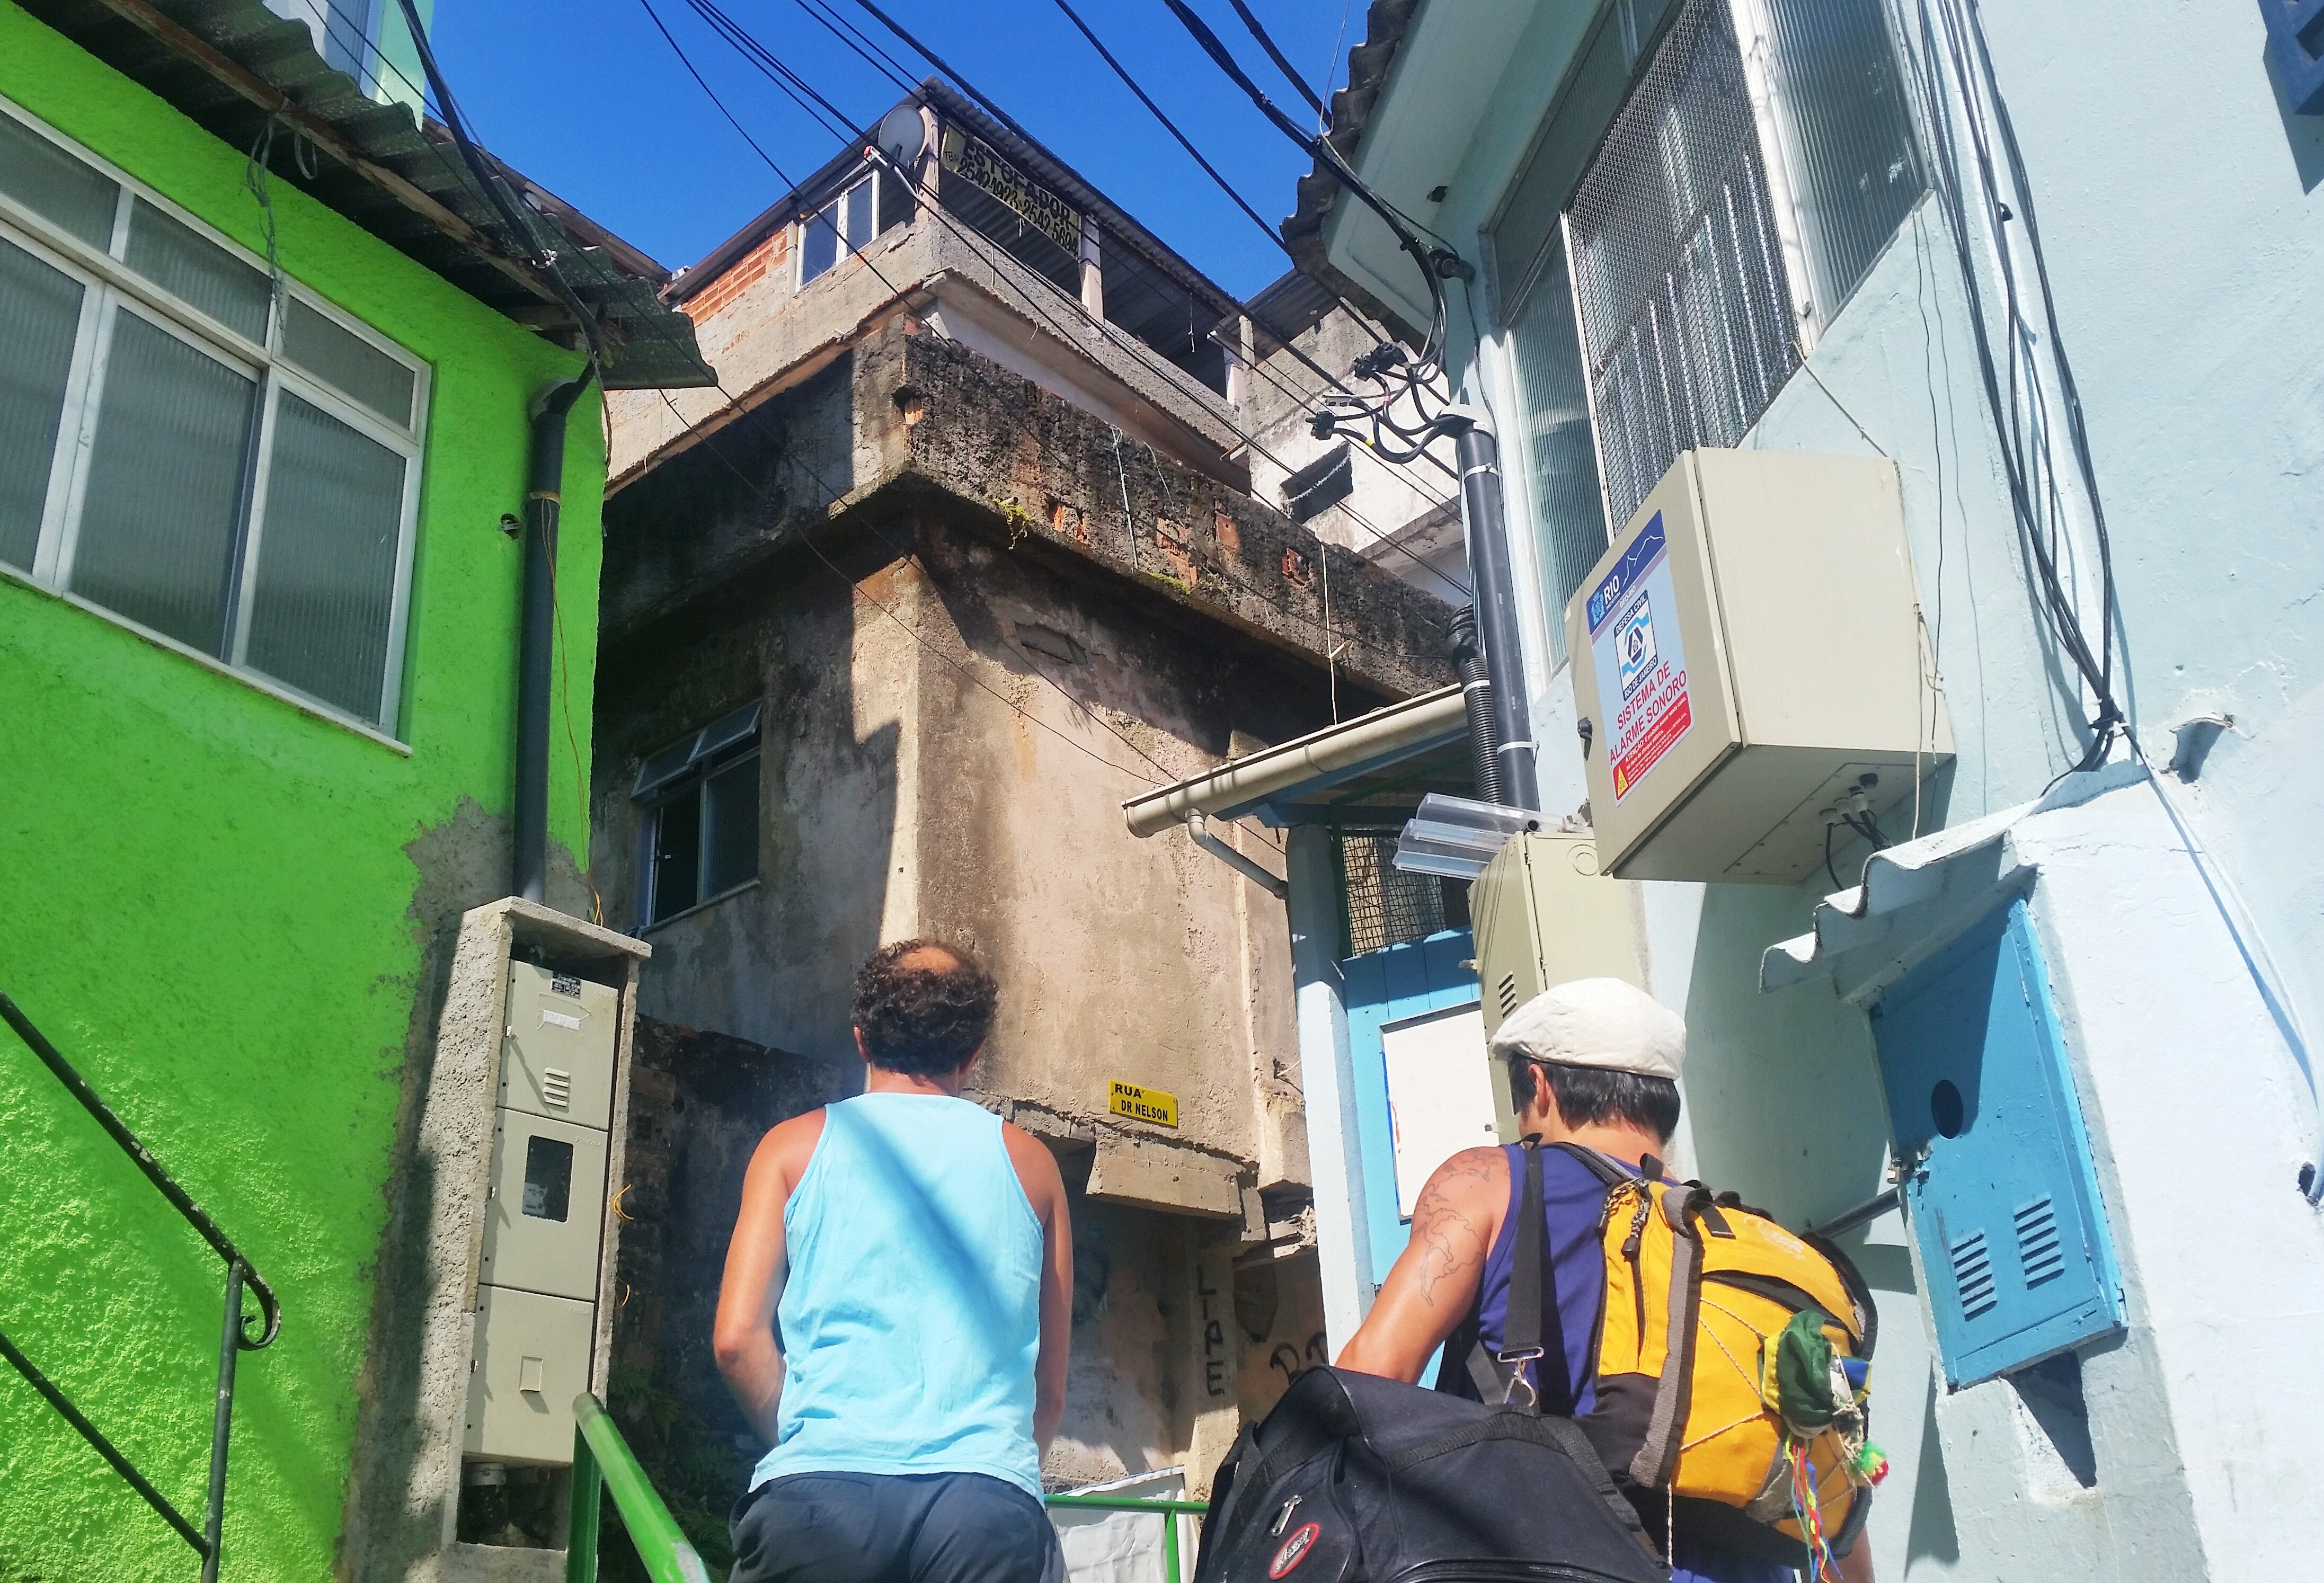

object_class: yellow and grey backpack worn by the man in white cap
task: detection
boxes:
[1471,1144,1887,1576]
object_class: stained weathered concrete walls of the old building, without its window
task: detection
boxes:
[592,325,1413,1483]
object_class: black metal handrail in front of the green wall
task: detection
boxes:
[0,995,283,1583]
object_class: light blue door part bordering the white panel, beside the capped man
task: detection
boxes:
[1341,930,1478,1292]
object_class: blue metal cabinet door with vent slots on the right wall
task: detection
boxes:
[1873,900,2122,1385]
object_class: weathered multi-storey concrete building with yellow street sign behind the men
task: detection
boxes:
[592,88,1450,1543]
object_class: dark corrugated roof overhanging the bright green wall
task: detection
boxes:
[19,0,716,390]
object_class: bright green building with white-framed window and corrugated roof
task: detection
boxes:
[0,0,711,1583]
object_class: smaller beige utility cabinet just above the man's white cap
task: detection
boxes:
[1469,830,1643,1144]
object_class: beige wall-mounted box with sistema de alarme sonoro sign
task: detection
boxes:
[1566,451,1952,886]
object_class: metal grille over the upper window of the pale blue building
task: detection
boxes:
[1566,0,1801,528]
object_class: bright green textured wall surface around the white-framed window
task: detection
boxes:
[0,0,604,1583]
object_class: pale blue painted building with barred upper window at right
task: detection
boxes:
[1255,0,2324,1583]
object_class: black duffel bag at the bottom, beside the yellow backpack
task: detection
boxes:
[1194,1369,1671,1583]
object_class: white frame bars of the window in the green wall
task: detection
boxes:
[0,97,432,751]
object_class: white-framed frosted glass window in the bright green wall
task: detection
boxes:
[0,101,423,730]
